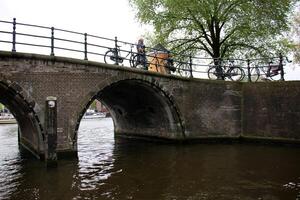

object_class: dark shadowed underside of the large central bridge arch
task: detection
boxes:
[73,79,185,148]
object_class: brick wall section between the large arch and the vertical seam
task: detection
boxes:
[177,79,242,139]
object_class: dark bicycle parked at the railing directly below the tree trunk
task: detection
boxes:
[207,61,245,81]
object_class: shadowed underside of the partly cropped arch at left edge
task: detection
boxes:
[0,80,44,159]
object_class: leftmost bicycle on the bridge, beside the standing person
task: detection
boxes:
[104,44,137,67]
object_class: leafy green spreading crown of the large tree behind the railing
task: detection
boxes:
[129,0,295,58]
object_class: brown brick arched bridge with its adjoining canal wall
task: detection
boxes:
[0,51,300,160]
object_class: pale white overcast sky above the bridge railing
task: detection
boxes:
[0,0,300,80]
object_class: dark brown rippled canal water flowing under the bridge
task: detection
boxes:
[0,118,300,200]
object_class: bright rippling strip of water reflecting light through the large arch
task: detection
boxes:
[75,118,115,190]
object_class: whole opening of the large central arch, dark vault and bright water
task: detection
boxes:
[73,79,185,158]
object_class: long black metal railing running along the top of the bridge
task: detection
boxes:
[0,18,289,82]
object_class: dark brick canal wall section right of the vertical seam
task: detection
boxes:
[241,81,300,142]
